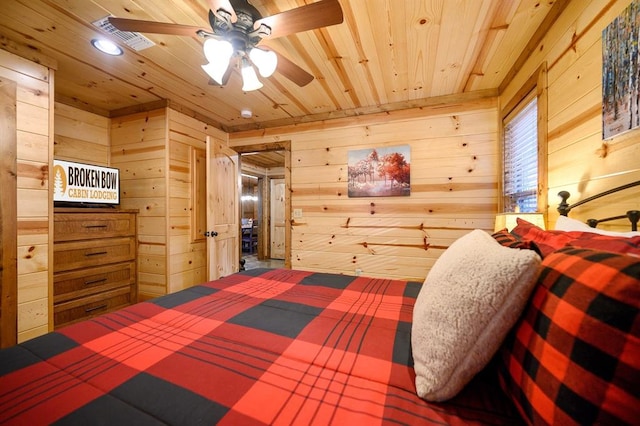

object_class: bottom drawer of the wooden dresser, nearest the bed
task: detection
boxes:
[53,286,133,327]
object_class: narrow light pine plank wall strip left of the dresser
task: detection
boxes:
[0,50,54,342]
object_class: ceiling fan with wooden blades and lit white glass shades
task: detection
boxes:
[109,0,343,91]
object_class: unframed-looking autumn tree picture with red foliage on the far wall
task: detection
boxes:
[348,145,411,197]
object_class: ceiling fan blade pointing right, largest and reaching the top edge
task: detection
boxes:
[254,0,344,38]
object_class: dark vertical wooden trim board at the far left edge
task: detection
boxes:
[0,78,18,348]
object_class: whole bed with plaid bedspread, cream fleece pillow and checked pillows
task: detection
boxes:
[0,181,640,425]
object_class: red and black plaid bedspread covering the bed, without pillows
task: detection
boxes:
[0,269,519,425]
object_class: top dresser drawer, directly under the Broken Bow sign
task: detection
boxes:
[53,213,136,242]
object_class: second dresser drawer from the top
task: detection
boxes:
[53,237,136,273]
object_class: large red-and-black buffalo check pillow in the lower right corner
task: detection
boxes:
[499,247,640,425]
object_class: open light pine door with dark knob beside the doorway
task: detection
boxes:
[205,137,240,280]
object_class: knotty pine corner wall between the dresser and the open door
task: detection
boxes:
[111,108,226,299]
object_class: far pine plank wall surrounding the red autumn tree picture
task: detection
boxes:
[230,98,498,281]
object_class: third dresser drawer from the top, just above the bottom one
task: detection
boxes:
[53,261,136,303]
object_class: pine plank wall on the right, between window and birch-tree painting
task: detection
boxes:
[500,0,640,230]
